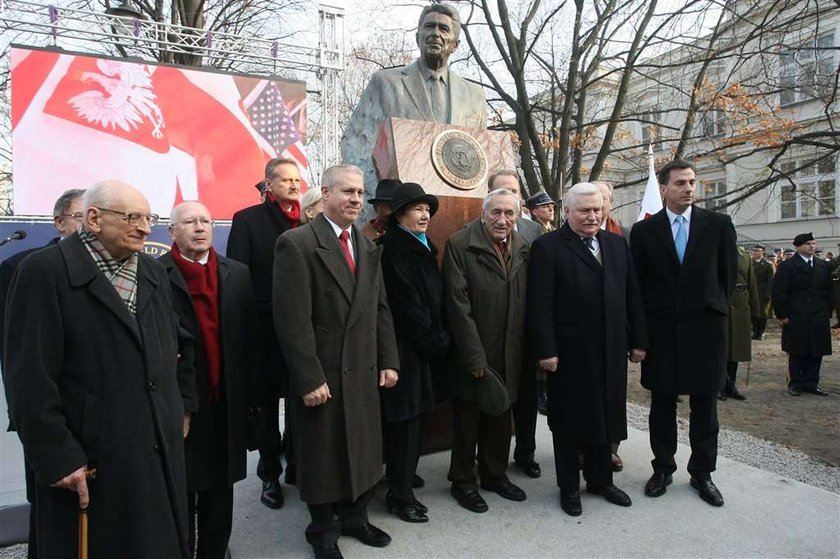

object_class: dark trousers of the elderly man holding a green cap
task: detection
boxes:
[449,399,511,489]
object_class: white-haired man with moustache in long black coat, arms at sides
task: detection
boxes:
[527,183,647,516]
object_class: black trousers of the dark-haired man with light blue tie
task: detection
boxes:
[649,392,720,481]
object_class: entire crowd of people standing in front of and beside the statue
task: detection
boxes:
[0,154,840,558]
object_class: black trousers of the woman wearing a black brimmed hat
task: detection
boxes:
[383,415,422,501]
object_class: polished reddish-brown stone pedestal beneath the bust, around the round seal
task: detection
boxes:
[372,118,516,453]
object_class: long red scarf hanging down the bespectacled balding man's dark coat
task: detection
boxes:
[172,243,222,402]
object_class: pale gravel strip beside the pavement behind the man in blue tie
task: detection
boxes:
[627,402,840,494]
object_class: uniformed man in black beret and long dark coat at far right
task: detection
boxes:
[773,233,831,396]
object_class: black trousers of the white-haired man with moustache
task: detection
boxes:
[551,429,613,494]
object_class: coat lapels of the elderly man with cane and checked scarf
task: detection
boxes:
[58,233,144,345]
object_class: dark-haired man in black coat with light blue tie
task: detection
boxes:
[630,160,737,506]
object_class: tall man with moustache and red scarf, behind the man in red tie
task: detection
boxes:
[227,158,300,509]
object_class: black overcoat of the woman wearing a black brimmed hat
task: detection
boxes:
[378,225,449,422]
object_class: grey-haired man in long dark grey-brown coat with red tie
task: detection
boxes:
[274,165,399,558]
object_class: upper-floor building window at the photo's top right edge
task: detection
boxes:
[779,30,836,107]
